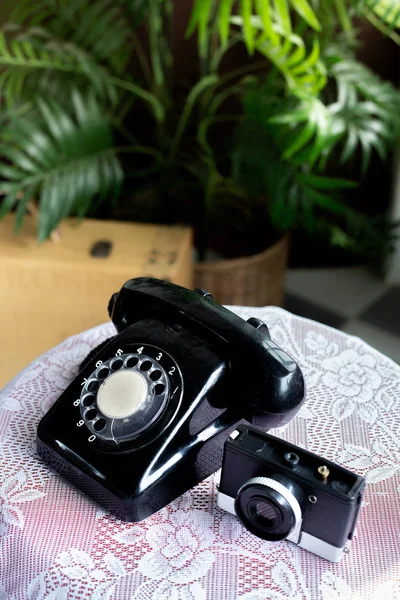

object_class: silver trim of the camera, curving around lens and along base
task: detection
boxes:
[217,477,351,562]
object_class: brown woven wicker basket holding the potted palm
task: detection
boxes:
[194,236,289,306]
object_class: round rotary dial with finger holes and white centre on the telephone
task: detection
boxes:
[79,346,177,443]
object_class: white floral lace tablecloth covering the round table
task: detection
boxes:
[0,308,400,600]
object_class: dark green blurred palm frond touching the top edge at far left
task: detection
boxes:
[11,0,133,72]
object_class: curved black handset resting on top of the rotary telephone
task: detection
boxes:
[112,277,304,418]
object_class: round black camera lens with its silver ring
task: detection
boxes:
[235,476,301,542]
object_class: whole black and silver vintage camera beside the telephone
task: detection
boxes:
[218,424,365,562]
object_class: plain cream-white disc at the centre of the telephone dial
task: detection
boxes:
[97,371,147,419]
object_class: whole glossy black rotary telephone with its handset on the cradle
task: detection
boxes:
[37,278,305,521]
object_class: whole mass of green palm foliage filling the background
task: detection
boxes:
[0,0,400,255]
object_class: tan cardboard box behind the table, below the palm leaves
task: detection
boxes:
[0,215,192,388]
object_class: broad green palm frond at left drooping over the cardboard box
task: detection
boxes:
[0,90,123,241]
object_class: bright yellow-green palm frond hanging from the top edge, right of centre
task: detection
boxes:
[187,0,321,52]
